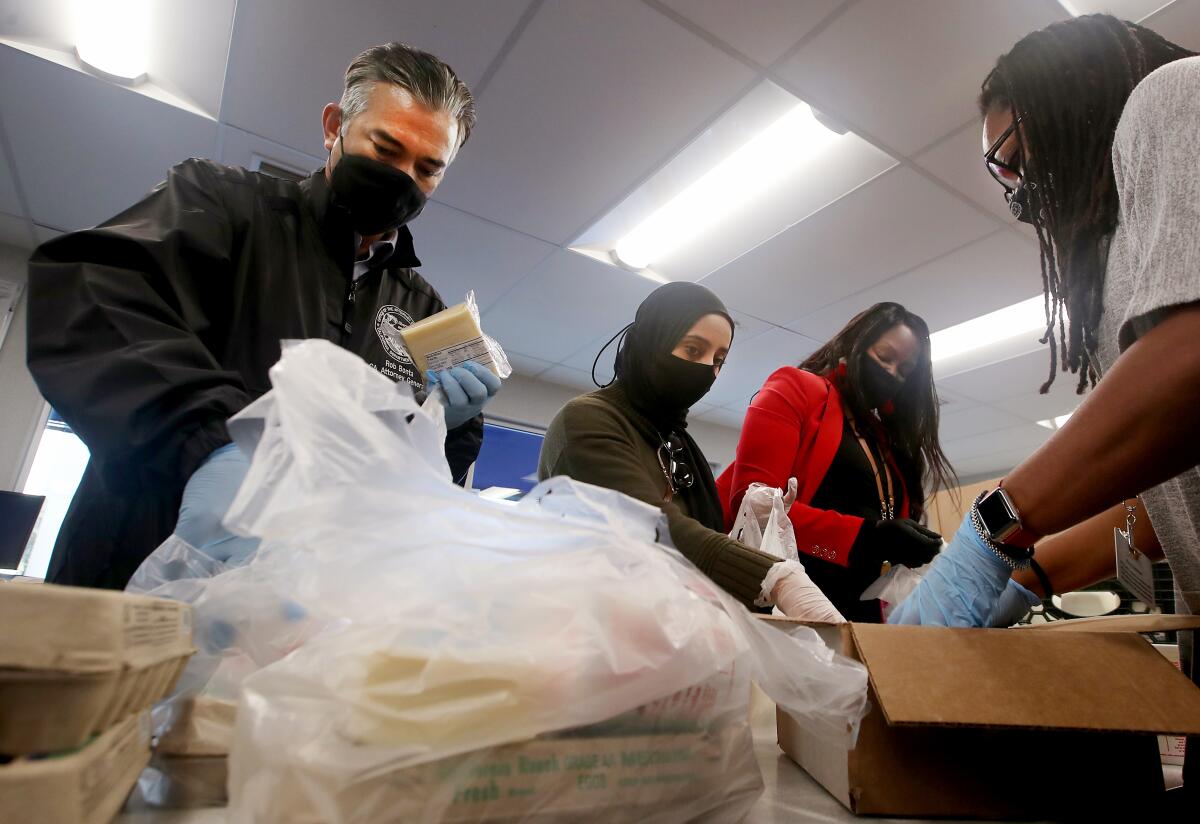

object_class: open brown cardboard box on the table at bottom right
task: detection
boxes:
[773,617,1200,820]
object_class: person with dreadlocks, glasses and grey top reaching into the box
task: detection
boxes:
[892,9,1200,793]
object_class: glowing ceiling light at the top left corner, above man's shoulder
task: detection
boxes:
[74,0,150,84]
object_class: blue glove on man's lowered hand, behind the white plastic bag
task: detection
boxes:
[175,444,258,566]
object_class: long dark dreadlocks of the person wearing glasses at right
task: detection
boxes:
[979,14,1193,393]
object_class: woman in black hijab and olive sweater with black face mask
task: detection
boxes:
[538,283,830,614]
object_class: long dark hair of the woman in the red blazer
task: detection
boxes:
[800,302,958,519]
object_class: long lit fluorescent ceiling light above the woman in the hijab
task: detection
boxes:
[613,103,842,270]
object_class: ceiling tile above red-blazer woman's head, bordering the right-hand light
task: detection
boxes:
[791,229,1042,341]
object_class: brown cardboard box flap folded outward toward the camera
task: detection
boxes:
[850,624,1200,734]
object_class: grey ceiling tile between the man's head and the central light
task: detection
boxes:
[438,0,754,243]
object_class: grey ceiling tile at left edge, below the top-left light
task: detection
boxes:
[0,46,217,229]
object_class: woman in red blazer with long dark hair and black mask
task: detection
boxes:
[716,303,953,621]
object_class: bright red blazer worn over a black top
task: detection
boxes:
[716,366,908,566]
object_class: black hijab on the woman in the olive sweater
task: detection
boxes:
[596,282,734,531]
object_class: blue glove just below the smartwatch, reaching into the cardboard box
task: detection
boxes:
[888,517,1013,626]
